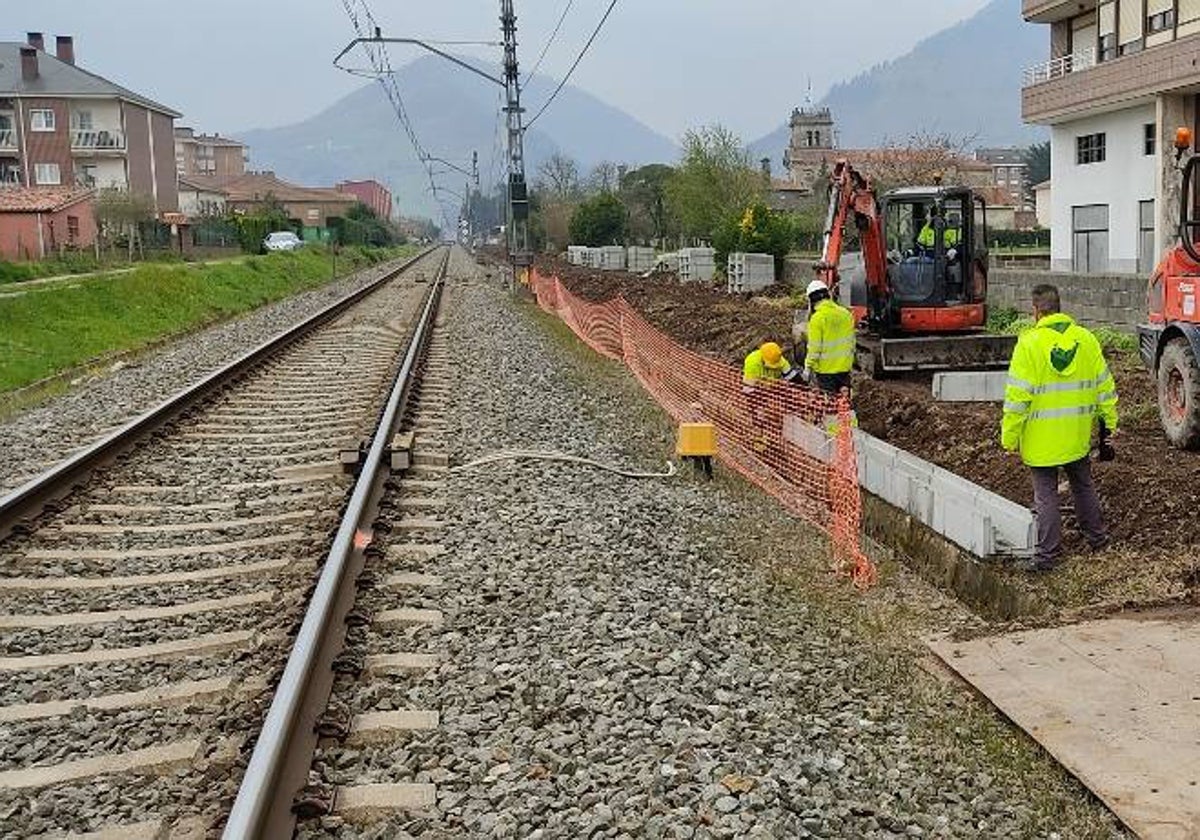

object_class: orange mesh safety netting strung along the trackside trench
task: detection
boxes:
[529,270,875,587]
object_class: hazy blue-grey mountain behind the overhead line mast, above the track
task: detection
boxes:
[238,56,679,220]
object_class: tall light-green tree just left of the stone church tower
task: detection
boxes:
[666,125,763,239]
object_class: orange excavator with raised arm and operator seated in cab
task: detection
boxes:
[815,161,1016,376]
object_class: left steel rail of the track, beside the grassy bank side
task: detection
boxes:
[0,246,442,540]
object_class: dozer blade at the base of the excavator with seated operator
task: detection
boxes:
[858,334,1016,376]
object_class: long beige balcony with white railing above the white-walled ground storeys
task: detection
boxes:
[1021,35,1200,125]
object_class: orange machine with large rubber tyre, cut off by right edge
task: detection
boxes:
[1138,128,1200,449]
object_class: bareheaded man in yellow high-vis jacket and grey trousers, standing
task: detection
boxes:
[1001,286,1117,571]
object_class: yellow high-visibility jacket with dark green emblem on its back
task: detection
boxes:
[1001,313,1117,467]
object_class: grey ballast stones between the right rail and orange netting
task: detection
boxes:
[312,255,1126,839]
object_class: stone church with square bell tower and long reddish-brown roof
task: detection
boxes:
[784,108,992,194]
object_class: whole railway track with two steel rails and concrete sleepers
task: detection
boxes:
[0,248,450,839]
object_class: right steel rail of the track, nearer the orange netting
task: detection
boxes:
[222,250,450,840]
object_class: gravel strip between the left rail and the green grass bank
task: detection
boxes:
[0,253,417,493]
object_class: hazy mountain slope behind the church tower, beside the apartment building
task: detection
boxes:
[750,0,1049,166]
